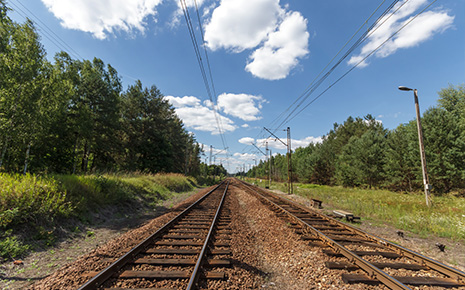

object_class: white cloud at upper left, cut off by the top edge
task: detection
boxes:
[42,0,162,39]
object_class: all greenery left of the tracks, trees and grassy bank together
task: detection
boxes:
[0,5,226,259]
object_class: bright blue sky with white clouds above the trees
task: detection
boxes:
[8,0,465,172]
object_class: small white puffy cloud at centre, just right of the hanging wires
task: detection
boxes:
[218,93,266,121]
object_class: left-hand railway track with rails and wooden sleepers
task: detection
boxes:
[79,181,231,290]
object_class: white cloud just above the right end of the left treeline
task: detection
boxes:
[165,96,237,135]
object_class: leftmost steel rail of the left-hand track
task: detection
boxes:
[78,181,225,290]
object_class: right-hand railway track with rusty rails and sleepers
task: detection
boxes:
[237,182,465,289]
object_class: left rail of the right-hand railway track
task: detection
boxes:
[239,183,411,290]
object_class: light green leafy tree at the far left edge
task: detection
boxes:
[0,17,49,172]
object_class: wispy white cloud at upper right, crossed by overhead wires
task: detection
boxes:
[348,0,455,67]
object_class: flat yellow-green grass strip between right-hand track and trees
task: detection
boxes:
[249,179,465,241]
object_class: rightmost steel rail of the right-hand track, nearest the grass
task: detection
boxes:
[250,184,465,284]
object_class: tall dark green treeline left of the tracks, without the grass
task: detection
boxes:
[0,0,201,176]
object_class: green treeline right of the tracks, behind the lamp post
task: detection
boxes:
[248,85,465,194]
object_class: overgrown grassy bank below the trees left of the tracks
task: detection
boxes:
[0,173,196,260]
